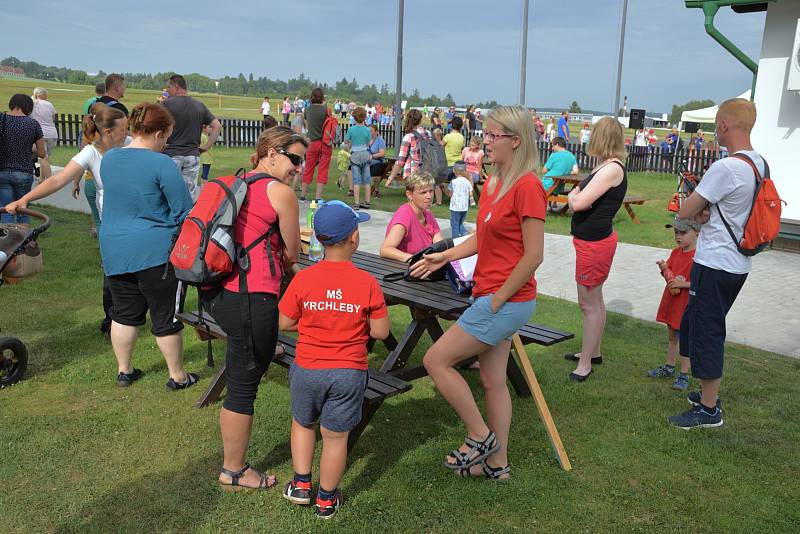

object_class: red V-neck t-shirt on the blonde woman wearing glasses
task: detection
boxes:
[472,173,547,302]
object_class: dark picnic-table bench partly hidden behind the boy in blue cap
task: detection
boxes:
[176,312,411,450]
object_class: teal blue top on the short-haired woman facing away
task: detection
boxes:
[100,148,192,276]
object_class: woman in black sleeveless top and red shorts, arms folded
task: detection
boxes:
[565,117,628,382]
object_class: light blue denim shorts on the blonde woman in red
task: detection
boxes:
[458,295,536,346]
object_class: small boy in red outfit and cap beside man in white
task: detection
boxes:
[647,217,700,391]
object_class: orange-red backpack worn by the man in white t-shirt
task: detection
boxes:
[717,154,785,256]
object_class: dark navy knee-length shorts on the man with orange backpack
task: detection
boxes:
[680,263,747,380]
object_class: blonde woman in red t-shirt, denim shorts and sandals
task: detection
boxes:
[412,106,547,480]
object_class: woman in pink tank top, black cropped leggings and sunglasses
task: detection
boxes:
[201,126,308,489]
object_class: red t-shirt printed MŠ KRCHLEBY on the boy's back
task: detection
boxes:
[278,260,389,371]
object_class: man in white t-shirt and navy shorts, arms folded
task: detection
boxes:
[669,98,765,430]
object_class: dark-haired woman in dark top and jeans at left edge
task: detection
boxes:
[0,93,50,224]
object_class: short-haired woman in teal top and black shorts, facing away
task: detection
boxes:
[100,103,198,391]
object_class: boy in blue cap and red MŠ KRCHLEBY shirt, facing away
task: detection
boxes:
[278,200,389,519]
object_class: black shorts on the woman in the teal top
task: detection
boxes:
[108,264,183,337]
